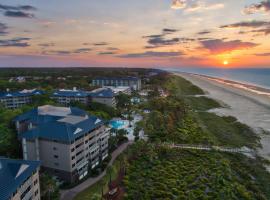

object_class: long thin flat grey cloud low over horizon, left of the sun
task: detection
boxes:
[118,51,184,58]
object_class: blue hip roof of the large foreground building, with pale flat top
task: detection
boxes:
[14,106,105,143]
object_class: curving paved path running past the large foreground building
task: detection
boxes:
[60,142,132,200]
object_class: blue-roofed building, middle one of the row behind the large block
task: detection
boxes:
[52,88,89,106]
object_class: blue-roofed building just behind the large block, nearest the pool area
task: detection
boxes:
[90,88,116,107]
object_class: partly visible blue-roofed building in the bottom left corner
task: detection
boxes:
[0,157,40,200]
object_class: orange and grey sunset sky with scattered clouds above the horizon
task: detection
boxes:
[0,0,270,67]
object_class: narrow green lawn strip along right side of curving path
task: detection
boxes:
[75,158,120,200]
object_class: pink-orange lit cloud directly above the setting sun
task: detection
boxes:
[201,39,258,54]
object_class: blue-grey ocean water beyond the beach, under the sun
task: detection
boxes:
[166,68,270,89]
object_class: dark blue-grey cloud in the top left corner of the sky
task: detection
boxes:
[0,4,37,18]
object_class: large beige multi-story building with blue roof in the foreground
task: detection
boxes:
[14,105,109,182]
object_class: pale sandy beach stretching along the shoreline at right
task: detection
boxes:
[177,73,270,160]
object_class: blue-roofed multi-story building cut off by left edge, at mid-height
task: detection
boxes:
[0,89,44,109]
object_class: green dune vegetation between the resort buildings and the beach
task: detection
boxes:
[123,74,270,199]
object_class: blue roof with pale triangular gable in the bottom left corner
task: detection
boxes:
[0,157,40,200]
